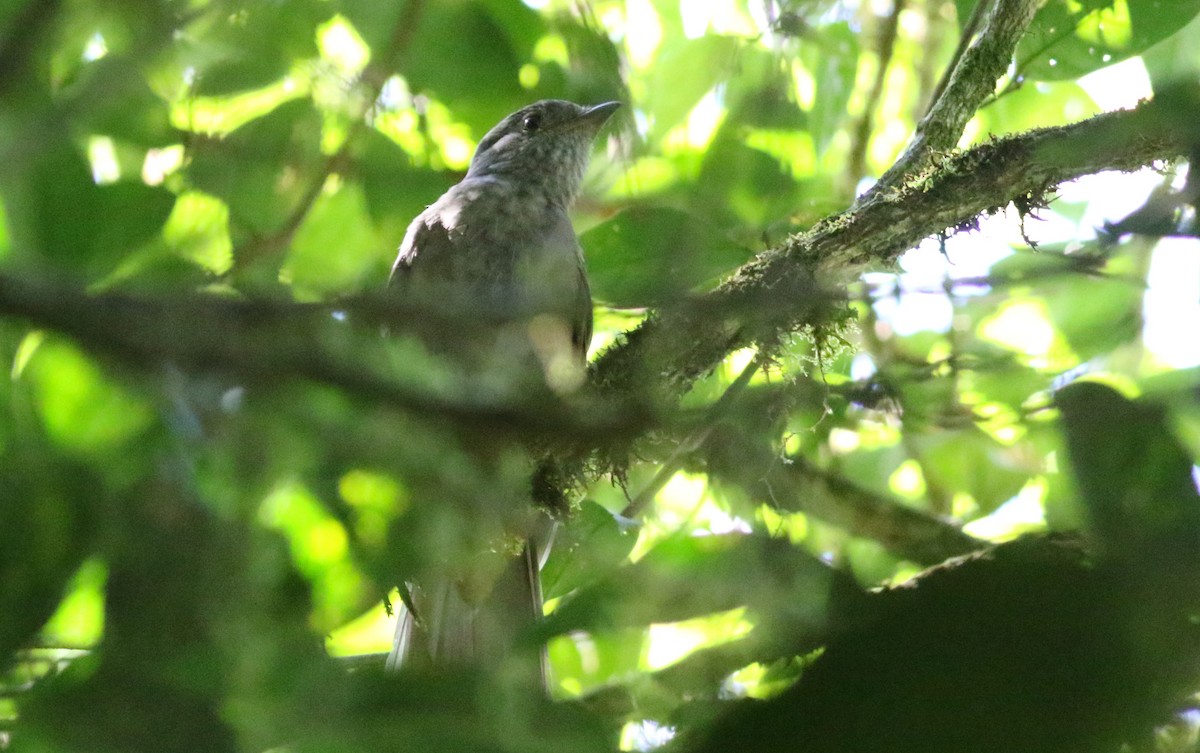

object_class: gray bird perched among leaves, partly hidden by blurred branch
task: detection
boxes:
[388,100,619,681]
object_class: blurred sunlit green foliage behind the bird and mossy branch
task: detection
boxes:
[0,0,1200,752]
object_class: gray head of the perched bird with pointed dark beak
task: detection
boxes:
[467,100,620,206]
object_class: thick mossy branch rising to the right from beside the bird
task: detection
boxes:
[594,102,1188,414]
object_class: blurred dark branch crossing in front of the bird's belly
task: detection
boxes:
[0,275,658,446]
